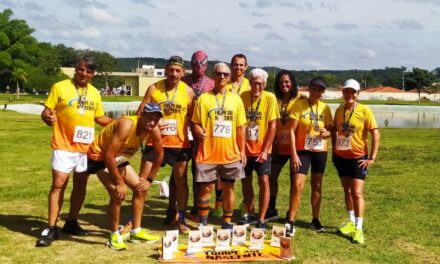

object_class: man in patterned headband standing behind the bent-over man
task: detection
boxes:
[138,56,195,233]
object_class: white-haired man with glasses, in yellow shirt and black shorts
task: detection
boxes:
[239,68,280,228]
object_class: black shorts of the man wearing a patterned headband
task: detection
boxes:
[142,146,191,167]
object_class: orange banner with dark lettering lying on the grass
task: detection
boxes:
[158,241,292,263]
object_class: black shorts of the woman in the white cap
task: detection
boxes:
[333,153,368,180]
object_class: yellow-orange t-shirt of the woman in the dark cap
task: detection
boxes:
[290,98,333,152]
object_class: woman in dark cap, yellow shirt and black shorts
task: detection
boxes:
[286,77,333,236]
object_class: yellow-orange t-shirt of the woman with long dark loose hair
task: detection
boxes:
[275,93,300,155]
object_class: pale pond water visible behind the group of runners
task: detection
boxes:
[8,101,440,128]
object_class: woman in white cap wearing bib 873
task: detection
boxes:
[332,79,380,244]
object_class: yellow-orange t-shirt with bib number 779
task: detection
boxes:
[192,91,246,164]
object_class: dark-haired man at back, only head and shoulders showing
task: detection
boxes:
[227,54,251,95]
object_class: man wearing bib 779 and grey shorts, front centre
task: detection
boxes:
[191,63,246,229]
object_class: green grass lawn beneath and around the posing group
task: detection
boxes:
[0,111,440,263]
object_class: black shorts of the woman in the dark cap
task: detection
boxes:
[297,150,327,175]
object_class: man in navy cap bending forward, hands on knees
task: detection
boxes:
[87,103,163,250]
